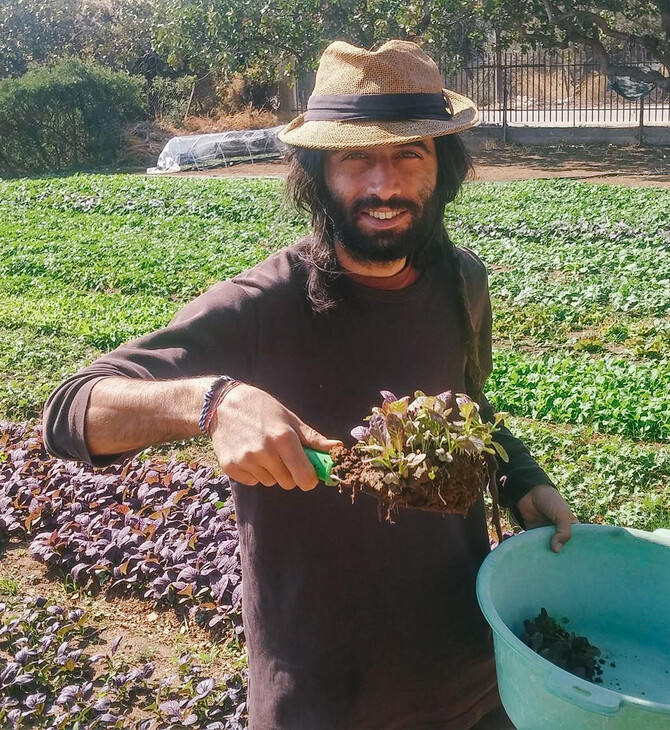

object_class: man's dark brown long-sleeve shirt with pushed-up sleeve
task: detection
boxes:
[44,246,549,730]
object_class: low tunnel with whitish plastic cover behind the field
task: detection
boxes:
[147,126,286,174]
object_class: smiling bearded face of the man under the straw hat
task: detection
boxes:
[324,139,437,262]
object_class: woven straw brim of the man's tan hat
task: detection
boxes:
[278,89,479,150]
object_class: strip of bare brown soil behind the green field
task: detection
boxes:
[164,145,670,189]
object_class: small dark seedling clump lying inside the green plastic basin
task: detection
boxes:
[521,608,604,684]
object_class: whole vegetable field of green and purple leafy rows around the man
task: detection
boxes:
[0,175,670,730]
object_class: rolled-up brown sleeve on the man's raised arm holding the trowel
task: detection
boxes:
[43,281,256,466]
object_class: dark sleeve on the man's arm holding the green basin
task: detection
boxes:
[468,246,555,527]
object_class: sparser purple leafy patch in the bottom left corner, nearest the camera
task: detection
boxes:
[0,597,246,730]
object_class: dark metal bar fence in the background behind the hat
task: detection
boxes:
[295,49,670,128]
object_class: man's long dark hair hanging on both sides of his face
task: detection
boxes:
[286,134,484,400]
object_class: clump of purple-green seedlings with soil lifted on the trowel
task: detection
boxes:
[331,390,507,521]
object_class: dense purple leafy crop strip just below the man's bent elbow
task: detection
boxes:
[0,422,242,631]
